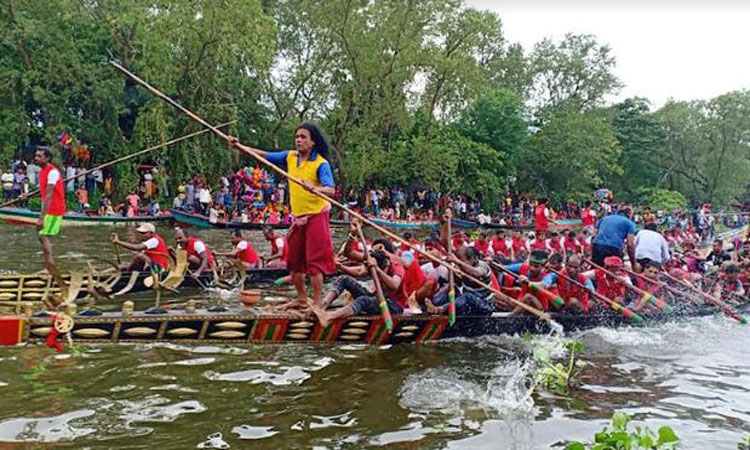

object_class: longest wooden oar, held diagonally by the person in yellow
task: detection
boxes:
[109,61,560,327]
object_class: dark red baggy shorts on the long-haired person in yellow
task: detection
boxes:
[286,209,336,275]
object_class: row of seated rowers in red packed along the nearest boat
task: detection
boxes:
[313,221,704,324]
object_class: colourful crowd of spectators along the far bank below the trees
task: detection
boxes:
[0,159,747,240]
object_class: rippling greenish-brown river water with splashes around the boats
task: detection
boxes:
[0,225,750,450]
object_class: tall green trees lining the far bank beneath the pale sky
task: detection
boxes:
[0,0,750,207]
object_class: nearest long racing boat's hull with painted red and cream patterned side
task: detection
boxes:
[0,307,736,345]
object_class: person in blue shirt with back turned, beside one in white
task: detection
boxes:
[591,207,638,271]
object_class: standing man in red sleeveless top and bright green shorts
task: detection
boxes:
[35,147,65,278]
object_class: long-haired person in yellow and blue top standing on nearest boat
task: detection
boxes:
[241,123,336,306]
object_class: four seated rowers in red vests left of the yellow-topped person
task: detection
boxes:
[112,222,288,277]
